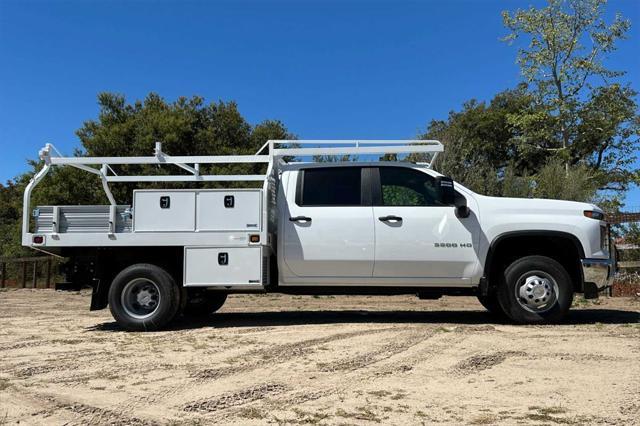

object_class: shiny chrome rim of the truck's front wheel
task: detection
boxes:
[515,271,559,314]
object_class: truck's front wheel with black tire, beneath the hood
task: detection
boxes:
[498,256,573,324]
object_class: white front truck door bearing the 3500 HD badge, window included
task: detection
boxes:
[372,166,479,284]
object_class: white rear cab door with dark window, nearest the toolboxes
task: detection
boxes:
[281,166,374,278]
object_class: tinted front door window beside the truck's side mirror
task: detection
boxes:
[379,167,444,206]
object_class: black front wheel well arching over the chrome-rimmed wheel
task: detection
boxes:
[484,232,584,292]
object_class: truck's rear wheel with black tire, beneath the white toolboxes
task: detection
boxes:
[109,263,180,331]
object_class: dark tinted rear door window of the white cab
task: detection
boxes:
[297,167,362,206]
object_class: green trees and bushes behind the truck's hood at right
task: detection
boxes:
[421,0,640,208]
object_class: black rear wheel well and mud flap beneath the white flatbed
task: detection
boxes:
[63,247,184,310]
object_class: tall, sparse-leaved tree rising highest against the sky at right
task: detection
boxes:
[503,0,640,191]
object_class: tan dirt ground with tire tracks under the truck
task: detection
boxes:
[0,290,640,425]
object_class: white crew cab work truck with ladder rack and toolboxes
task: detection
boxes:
[22,140,615,330]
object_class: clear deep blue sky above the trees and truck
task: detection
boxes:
[0,0,640,205]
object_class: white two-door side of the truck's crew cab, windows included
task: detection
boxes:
[278,163,481,287]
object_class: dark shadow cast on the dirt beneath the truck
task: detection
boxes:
[87,309,640,331]
